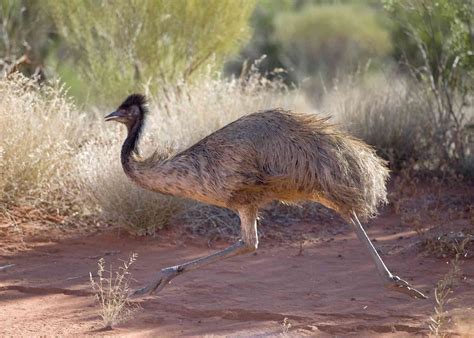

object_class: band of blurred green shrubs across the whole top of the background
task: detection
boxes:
[0,0,474,104]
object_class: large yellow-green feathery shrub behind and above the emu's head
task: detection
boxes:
[47,0,255,102]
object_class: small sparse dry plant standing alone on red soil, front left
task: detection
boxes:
[89,253,137,329]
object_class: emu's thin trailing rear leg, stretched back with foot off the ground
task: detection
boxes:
[351,212,427,299]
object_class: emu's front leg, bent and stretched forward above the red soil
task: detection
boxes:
[133,209,258,295]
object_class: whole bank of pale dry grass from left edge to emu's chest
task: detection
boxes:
[0,74,183,233]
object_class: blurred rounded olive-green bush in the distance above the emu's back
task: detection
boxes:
[227,0,393,97]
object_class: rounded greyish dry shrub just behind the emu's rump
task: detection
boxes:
[322,77,430,169]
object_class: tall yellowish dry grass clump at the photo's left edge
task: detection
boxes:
[0,74,82,217]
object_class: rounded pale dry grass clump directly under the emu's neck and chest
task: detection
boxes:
[76,138,182,235]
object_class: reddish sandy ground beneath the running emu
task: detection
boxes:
[0,184,474,337]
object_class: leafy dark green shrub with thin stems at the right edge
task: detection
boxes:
[385,0,474,171]
